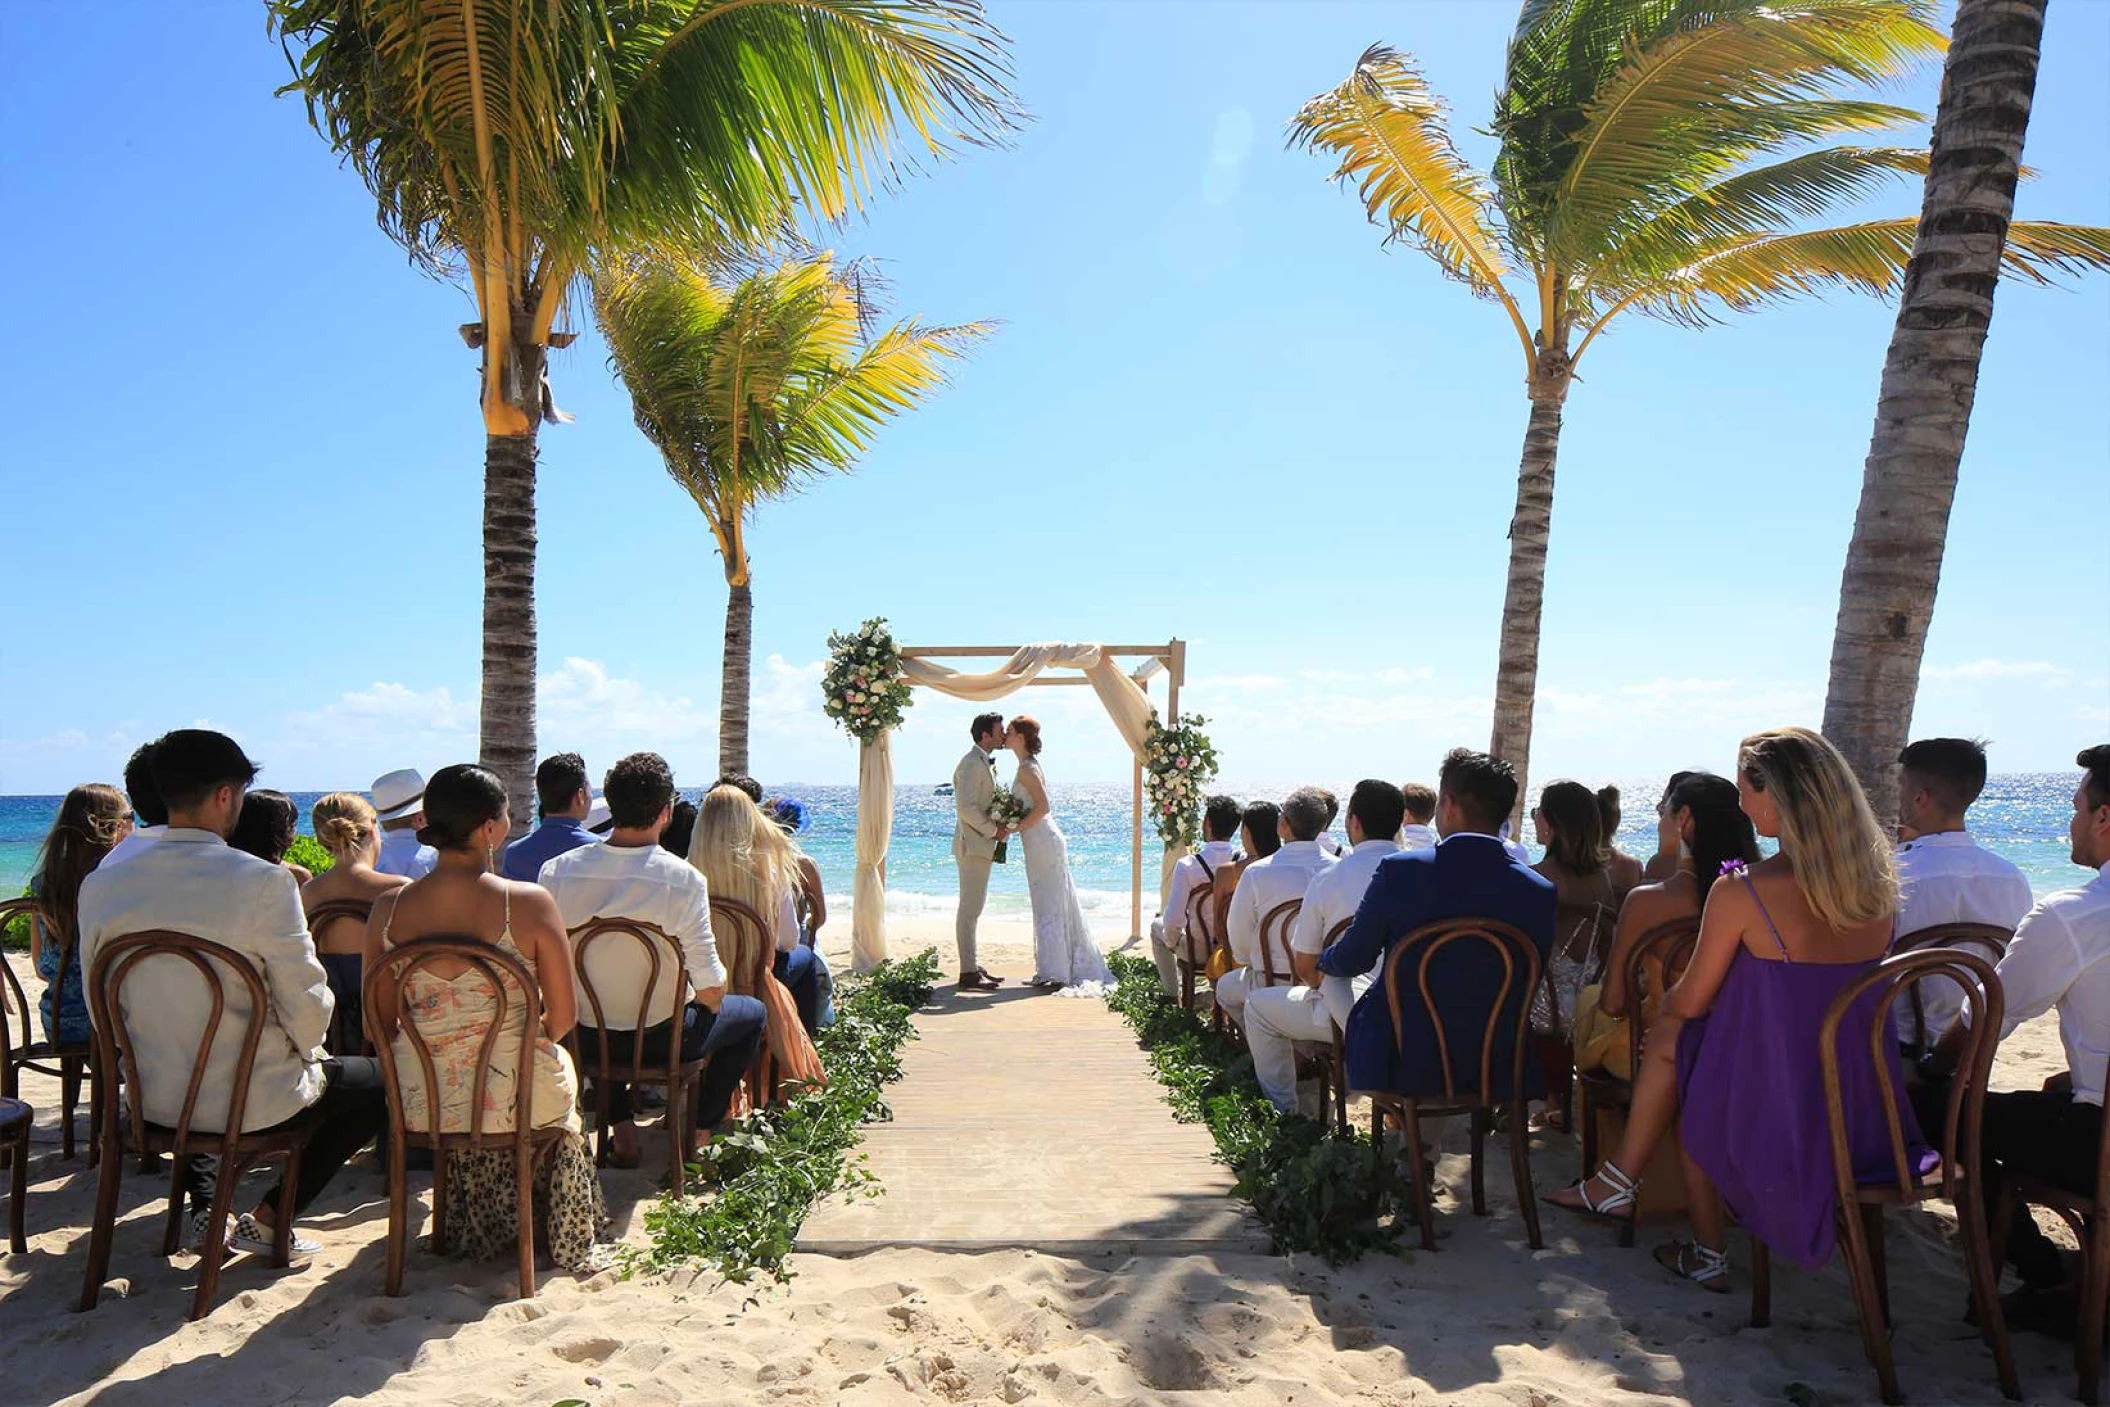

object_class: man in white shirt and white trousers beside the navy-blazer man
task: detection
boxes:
[1245,780,1407,1114]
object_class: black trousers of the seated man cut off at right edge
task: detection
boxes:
[1912,1082,2104,1289]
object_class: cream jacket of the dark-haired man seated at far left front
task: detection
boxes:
[80,827,335,1133]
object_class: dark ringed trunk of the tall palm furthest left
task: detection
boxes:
[477,335,544,835]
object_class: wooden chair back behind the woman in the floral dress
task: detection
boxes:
[363,932,542,1158]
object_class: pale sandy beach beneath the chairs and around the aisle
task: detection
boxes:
[0,922,2072,1407]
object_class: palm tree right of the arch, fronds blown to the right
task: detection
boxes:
[1289,0,2110,826]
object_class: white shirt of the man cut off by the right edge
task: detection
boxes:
[1998,865,2110,1105]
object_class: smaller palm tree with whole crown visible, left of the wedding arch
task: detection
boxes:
[593,253,990,772]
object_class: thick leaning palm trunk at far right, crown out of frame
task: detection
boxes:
[1825,0,2047,827]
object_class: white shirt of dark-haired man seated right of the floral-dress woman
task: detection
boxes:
[538,844,726,1032]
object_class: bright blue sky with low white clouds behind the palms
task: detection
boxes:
[0,0,2110,793]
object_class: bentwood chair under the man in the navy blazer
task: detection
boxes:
[1369,918,1545,1251]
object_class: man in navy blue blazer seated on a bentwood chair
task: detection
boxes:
[1319,747,1555,1099]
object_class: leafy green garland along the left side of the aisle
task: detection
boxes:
[629,949,937,1283]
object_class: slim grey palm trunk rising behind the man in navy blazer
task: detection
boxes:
[1488,367,1568,835]
